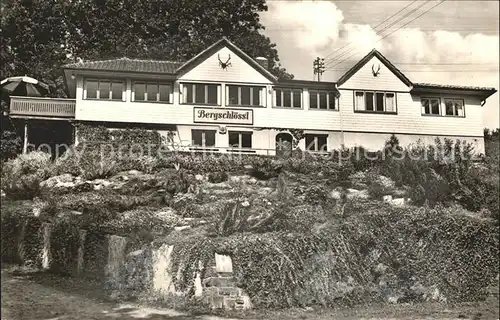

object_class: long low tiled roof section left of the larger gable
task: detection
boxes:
[63,58,183,75]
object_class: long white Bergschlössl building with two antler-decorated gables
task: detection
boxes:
[10,38,496,154]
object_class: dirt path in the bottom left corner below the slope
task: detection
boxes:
[2,269,232,320]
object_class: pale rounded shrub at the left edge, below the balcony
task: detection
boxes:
[1,151,51,199]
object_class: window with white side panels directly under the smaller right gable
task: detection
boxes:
[354,91,396,113]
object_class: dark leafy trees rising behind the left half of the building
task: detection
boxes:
[0,0,293,96]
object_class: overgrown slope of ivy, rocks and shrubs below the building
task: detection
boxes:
[2,127,499,307]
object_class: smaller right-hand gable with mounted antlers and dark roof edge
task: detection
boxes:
[338,50,412,92]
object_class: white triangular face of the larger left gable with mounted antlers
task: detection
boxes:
[177,38,276,84]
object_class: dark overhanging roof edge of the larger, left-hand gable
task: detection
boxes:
[177,37,278,81]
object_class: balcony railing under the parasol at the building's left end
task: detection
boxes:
[10,97,76,118]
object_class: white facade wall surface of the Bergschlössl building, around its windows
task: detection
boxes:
[75,48,484,154]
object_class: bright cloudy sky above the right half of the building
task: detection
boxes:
[260,0,500,128]
